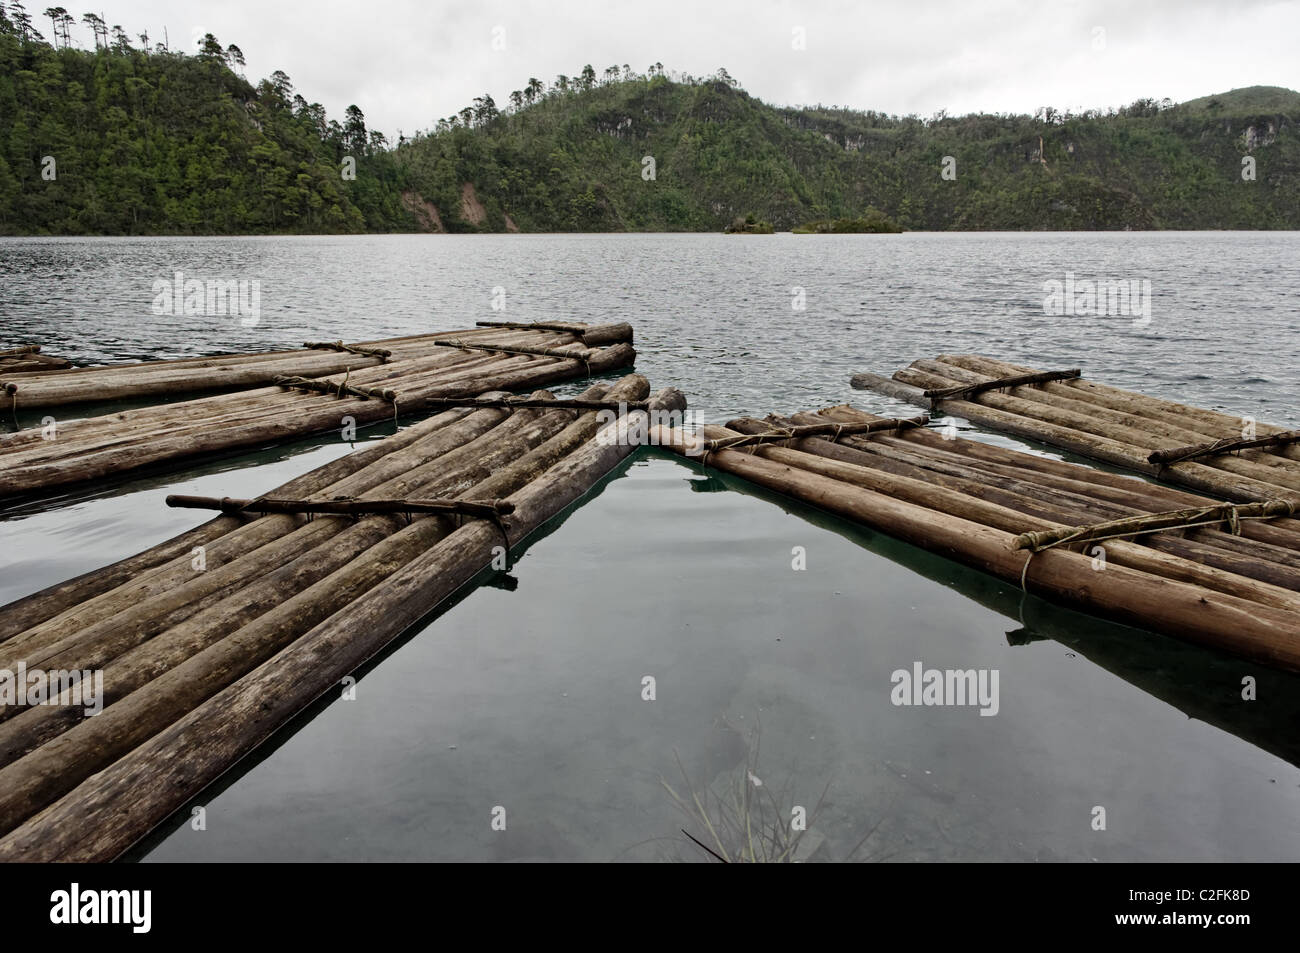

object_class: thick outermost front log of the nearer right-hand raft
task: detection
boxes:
[653,428,1300,671]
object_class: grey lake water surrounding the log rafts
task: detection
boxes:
[0,233,1300,861]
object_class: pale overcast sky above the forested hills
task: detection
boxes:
[63,0,1300,138]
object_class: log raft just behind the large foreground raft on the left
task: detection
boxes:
[0,329,636,498]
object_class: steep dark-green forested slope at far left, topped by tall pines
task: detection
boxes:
[0,3,415,235]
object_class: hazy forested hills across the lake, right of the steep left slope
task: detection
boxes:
[397,70,1300,231]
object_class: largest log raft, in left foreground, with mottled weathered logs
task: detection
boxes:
[0,374,685,862]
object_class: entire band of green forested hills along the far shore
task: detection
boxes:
[0,0,1300,234]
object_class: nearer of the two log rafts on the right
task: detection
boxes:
[651,397,1300,671]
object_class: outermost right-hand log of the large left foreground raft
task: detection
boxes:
[0,374,680,861]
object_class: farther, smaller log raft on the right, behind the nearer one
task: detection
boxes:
[852,354,1300,503]
